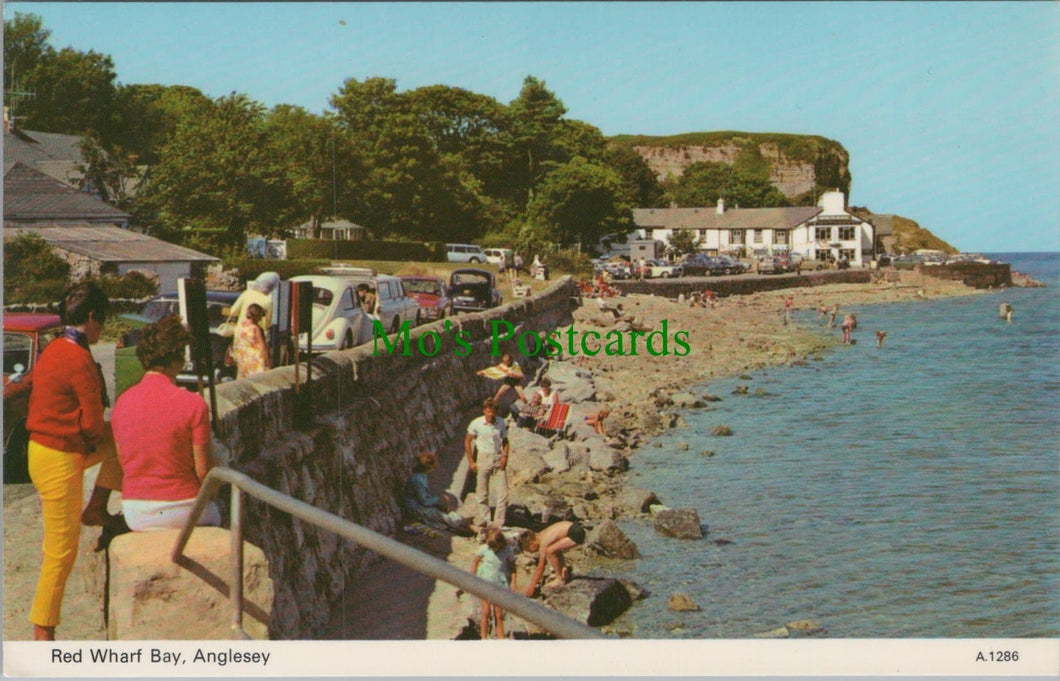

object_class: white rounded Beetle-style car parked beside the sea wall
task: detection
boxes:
[290,275,372,352]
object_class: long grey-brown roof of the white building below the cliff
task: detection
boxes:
[633,206,822,229]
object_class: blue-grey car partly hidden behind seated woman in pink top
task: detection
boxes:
[114,291,240,397]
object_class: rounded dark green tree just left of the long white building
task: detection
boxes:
[527,157,633,245]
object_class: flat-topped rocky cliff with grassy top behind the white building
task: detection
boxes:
[611,132,850,205]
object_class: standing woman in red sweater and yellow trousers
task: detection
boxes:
[25,283,122,641]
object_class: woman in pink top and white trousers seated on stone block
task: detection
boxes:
[110,315,220,530]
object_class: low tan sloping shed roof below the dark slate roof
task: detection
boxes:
[3,223,219,263]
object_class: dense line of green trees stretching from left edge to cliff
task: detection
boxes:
[4,13,801,252]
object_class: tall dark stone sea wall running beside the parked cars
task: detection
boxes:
[207,278,573,639]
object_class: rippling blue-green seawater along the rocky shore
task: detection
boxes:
[617,254,1060,639]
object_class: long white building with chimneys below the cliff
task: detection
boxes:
[633,192,872,265]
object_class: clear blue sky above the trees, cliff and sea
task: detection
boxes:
[4,2,1060,251]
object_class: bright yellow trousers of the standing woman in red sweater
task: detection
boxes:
[29,423,122,627]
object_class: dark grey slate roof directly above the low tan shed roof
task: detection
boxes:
[3,161,130,225]
